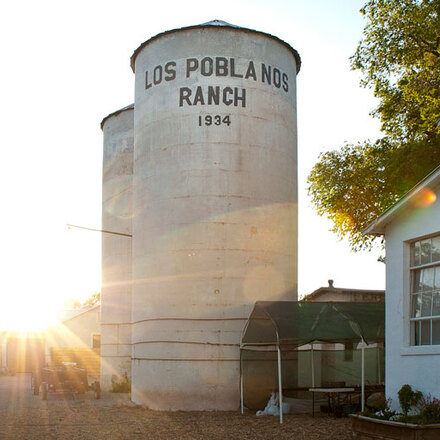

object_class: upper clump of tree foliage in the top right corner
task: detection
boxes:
[351,0,440,142]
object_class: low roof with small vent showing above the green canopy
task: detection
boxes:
[302,280,385,302]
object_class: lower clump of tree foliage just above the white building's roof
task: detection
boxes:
[308,138,440,250]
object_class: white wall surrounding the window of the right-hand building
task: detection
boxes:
[385,182,440,407]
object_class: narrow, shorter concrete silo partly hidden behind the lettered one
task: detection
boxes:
[101,105,134,389]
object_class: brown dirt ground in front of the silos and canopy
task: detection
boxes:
[0,375,351,440]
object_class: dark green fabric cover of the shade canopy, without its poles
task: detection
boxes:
[241,301,385,349]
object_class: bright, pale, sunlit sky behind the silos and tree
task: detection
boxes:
[0,0,385,329]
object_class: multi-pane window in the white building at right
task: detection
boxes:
[410,235,440,345]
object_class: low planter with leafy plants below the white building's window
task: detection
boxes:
[351,384,440,440]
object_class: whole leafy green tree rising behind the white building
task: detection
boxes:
[308,0,440,250]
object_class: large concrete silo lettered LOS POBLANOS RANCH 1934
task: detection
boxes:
[131,20,300,410]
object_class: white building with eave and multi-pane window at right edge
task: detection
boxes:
[364,167,440,406]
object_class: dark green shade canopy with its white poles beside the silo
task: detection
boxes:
[240,301,385,423]
